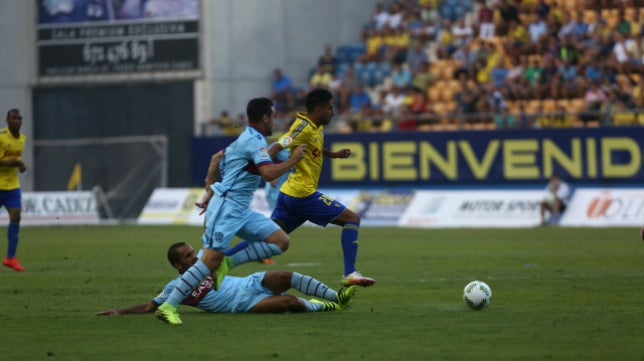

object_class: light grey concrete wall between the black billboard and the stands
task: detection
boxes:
[203,0,377,128]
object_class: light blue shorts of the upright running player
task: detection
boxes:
[201,196,280,253]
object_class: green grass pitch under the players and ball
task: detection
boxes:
[0,225,644,361]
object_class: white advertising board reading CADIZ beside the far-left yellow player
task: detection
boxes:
[0,192,99,226]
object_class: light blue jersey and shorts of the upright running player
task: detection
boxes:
[202,127,280,253]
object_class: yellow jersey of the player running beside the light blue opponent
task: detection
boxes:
[278,113,324,198]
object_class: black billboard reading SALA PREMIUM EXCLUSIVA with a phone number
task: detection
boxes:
[37,0,200,77]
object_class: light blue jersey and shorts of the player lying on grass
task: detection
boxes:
[152,272,274,313]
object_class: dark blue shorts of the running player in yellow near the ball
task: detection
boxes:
[271,192,347,233]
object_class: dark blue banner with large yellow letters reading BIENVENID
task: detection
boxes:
[192,128,644,188]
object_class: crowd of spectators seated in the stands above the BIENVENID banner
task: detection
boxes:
[266,0,644,132]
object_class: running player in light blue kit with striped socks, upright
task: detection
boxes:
[156,98,306,325]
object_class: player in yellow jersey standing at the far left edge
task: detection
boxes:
[0,109,27,272]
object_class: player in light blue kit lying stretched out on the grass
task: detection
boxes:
[97,242,355,316]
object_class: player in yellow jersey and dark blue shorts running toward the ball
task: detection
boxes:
[269,89,375,287]
